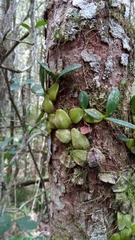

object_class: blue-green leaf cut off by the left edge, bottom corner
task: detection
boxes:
[0,214,12,236]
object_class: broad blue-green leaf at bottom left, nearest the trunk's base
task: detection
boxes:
[15,216,37,231]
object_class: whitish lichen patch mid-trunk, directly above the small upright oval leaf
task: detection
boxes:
[81,50,101,73]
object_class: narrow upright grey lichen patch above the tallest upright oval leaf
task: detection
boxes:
[102,55,114,80]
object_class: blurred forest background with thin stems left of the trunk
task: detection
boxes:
[0,0,49,240]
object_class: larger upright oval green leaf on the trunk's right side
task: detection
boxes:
[106,88,120,117]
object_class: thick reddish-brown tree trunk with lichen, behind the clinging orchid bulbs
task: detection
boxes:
[46,0,133,240]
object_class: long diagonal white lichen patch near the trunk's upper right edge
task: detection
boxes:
[110,19,131,51]
